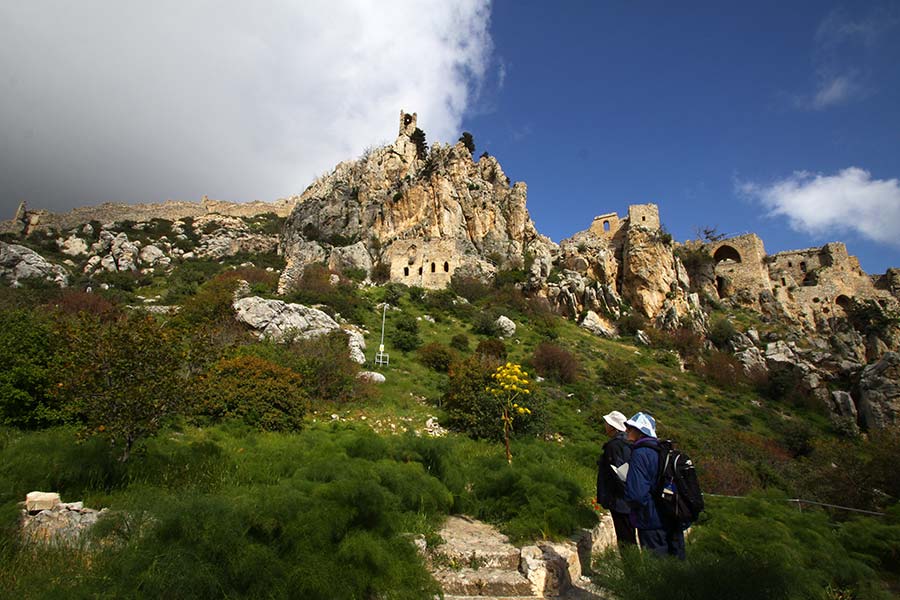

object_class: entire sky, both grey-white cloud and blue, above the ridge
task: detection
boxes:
[0,0,900,273]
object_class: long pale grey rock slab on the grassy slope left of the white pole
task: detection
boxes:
[232,296,366,364]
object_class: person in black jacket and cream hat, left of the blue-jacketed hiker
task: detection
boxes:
[597,410,637,547]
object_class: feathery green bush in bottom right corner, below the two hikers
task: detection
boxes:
[594,497,900,600]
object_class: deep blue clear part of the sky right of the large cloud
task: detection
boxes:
[463,1,900,272]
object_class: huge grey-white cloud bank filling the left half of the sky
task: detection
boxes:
[0,0,492,212]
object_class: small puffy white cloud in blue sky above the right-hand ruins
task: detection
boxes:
[736,167,900,246]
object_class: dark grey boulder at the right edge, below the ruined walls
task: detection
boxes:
[859,352,900,429]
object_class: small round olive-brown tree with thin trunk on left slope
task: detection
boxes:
[51,312,188,462]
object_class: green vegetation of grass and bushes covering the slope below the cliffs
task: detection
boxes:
[0,251,900,600]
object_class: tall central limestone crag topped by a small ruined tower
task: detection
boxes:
[280,112,555,290]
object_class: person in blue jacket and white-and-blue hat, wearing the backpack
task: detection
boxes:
[625,412,684,560]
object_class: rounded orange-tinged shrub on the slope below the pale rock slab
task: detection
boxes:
[198,356,308,431]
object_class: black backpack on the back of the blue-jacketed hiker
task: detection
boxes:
[654,440,703,523]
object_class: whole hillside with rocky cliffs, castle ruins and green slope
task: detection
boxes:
[0,113,900,598]
